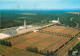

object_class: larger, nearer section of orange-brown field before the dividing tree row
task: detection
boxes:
[8,32,71,52]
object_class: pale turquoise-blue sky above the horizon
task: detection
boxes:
[0,0,80,10]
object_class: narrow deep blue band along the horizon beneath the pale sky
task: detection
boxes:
[0,9,80,13]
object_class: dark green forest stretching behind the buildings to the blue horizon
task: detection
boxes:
[0,10,80,29]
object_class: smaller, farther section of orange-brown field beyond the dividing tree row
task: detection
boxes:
[41,25,80,37]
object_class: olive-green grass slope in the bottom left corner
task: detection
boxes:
[0,45,43,56]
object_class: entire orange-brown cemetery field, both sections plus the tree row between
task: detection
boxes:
[7,26,79,53]
